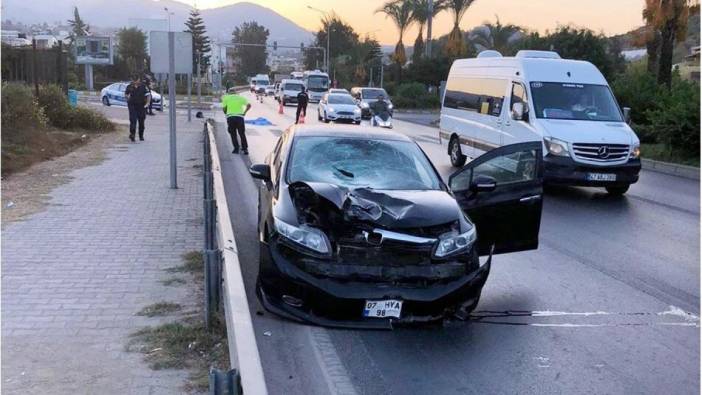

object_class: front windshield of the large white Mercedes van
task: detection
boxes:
[531,82,622,122]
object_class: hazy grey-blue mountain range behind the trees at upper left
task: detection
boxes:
[2,0,312,46]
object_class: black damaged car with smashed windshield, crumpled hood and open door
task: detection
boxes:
[250,125,543,328]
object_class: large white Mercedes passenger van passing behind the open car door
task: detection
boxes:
[439,51,641,195]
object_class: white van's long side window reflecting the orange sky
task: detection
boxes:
[444,77,507,117]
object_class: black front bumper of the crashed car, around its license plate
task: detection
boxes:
[257,240,492,329]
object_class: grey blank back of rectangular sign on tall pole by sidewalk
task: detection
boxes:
[149,31,193,74]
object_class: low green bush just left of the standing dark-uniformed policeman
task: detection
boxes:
[38,85,115,132]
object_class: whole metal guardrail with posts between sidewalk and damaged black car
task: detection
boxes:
[203,120,268,395]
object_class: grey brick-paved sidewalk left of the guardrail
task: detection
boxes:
[1,110,203,394]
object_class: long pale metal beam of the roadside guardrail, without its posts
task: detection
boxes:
[207,122,268,395]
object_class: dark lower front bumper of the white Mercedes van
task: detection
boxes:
[544,155,641,187]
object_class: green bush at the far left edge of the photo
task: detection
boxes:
[1,82,47,131]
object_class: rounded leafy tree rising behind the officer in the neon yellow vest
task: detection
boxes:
[232,21,270,82]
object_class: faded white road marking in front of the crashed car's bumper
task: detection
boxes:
[307,327,357,395]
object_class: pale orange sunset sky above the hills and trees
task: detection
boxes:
[169,0,644,45]
